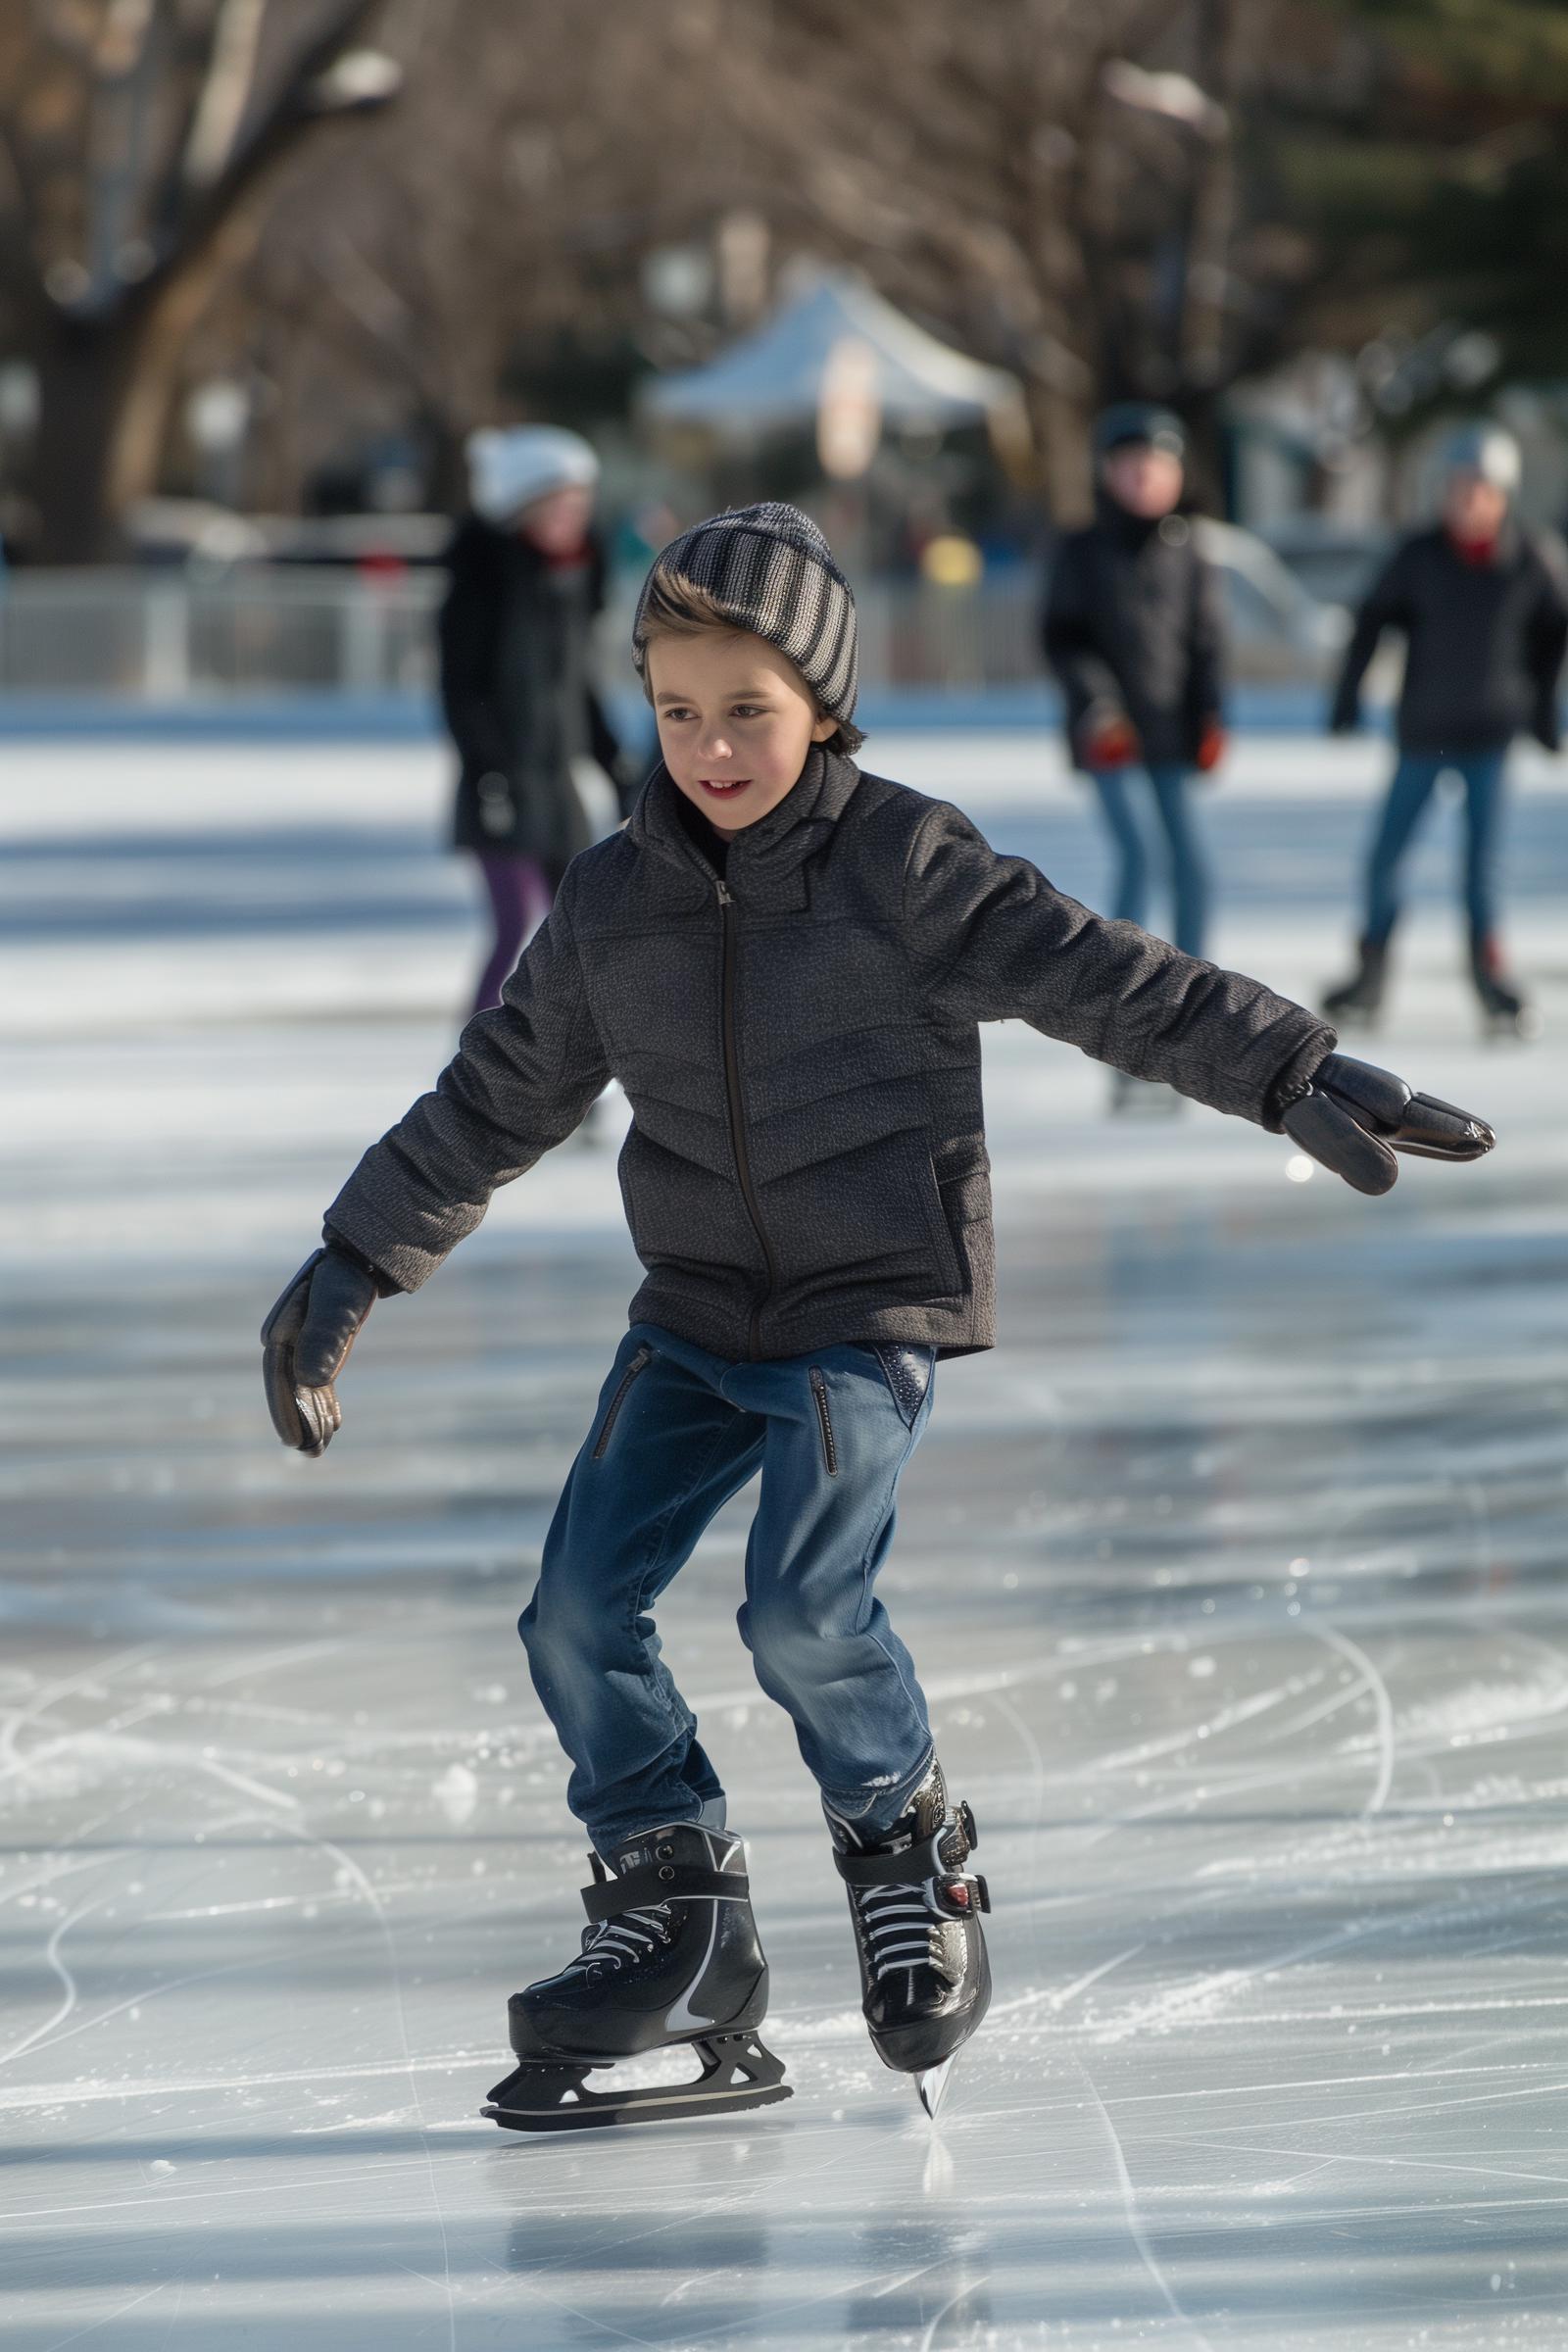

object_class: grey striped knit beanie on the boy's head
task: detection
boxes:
[632,501,860,751]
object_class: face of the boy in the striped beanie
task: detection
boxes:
[649,630,839,833]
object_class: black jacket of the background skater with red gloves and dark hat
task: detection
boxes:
[1042,496,1225,766]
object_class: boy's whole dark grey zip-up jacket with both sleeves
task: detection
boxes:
[326,751,1333,1359]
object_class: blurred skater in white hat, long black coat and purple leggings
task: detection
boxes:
[440,425,630,1011]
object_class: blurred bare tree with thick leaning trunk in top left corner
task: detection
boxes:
[0,0,397,563]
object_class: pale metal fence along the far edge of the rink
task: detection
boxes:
[0,566,1316,704]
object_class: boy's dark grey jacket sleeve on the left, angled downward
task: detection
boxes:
[326,882,609,1292]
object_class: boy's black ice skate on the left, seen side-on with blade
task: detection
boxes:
[482,1823,790,2131]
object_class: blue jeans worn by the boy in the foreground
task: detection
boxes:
[517,1324,933,1856]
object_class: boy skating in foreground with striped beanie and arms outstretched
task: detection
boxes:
[264,506,1491,2129]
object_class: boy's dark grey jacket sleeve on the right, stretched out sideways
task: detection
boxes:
[906,802,1336,1129]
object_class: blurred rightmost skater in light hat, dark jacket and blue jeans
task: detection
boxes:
[1324,425,1568,1035]
